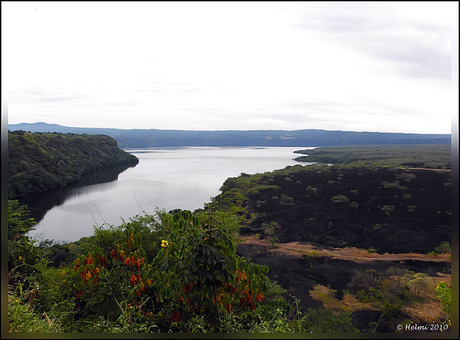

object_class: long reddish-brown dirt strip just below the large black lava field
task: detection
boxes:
[239,235,450,262]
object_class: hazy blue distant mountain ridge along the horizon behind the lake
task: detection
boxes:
[8,122,451,148]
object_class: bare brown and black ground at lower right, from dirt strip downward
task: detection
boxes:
[239,235,451,333]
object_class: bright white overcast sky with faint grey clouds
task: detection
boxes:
[1,1,458,133]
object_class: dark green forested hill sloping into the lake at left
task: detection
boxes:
[8,131,139,199]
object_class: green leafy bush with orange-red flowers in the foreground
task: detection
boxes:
[74,211,270,331]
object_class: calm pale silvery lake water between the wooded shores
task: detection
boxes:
[29,147,313,242]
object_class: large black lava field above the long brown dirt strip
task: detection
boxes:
[245,167,452,253]
